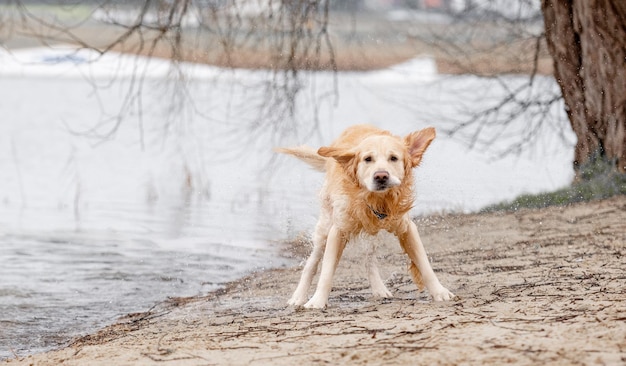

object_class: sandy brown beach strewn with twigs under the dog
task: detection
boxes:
[6,197,626,365]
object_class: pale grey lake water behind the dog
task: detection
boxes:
[0,49,573,359]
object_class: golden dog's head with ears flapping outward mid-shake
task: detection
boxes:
[317,127,435,193]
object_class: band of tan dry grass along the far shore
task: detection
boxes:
[0,16,553,76]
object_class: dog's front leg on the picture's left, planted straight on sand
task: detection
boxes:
[304,225,347,309]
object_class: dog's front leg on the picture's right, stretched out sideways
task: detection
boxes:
[398,218,454,301]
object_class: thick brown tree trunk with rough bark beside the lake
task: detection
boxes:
[541,0,626,176]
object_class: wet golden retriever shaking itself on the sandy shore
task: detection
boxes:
[276,125,454,308]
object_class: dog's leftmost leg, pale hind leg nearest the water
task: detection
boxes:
[287,217,329,306]
